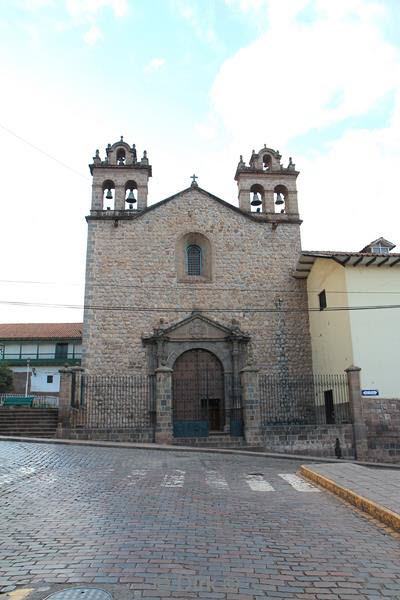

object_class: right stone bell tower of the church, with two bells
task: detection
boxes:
[235,144,299,221]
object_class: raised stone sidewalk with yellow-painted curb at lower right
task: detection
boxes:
[300,463,400,531]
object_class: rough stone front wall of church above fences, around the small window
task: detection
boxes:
[82,188,311,375]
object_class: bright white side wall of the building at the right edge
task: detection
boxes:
[343,265,400,398]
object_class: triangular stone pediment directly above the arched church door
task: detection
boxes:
[144,312,248,341]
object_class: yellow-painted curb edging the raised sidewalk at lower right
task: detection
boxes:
[300,465,400,531]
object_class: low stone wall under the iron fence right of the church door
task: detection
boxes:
[263,425,354,458]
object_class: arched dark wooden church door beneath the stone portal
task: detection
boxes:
[172,348,225,437]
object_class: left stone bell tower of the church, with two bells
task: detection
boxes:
[89,136,152,212]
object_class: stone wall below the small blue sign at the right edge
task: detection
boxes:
[362,398,400,463]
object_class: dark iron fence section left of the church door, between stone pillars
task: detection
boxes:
[70,374,156,429]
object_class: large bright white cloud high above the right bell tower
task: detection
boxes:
[211,0,400,145]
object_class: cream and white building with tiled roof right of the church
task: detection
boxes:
[295,238,400,398]
